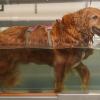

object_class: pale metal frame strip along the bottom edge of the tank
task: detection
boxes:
[0,94,100,100]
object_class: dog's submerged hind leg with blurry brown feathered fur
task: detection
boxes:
[0,59,19,92]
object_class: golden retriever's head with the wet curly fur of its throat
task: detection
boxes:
[62,7,100,46]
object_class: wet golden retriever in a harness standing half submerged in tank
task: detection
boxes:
[0,8,100,92]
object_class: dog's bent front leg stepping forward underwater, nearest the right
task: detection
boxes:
[75,62,90,90]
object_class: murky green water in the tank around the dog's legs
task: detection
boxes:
[0,49,100,93]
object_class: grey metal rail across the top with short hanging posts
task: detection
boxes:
[0,0,99,14]
